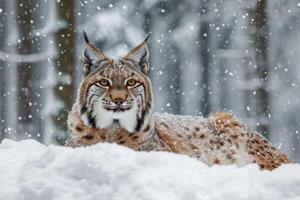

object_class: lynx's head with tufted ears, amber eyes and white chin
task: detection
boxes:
[78,34,153,133]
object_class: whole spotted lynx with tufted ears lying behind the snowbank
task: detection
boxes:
[68,34,289,170]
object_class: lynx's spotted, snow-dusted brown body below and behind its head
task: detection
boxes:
[68,104,289,170]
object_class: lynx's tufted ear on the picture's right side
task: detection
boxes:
[124,33,150,74]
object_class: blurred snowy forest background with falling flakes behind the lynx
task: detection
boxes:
[0,0,300,162]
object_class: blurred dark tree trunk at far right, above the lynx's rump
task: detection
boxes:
[250,0,270,137]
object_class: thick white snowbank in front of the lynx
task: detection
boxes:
[0,139,300,200]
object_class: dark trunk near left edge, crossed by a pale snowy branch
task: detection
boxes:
[16,0,36,139]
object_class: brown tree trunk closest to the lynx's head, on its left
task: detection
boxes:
[54,0,76,142]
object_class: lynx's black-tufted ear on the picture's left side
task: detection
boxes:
[82,32,109,76]
